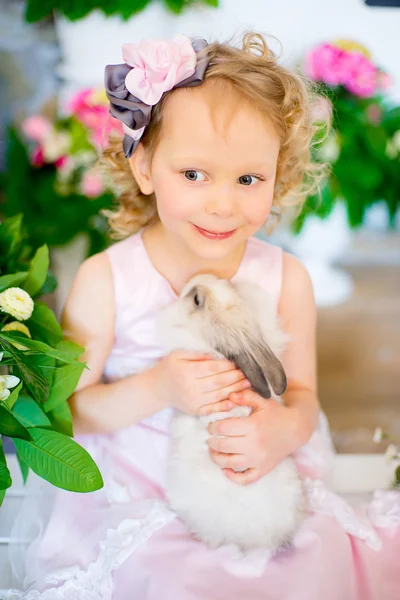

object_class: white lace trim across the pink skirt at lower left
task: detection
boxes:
[0,500,175,600]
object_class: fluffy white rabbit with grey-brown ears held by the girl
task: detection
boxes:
[159,275,305,552]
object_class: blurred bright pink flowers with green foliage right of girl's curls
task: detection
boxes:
[295,40,400,231]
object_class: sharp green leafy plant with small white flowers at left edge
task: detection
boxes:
[0,215,103,505]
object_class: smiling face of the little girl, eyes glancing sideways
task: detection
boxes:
[134,85,279,260]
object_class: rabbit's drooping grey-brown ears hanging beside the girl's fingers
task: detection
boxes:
[216,331,287,398]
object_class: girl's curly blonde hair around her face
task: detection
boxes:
[100,32,329,239]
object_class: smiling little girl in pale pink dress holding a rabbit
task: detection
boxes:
[3,34,400,600]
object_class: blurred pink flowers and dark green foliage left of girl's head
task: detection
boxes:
[2,89,122,254]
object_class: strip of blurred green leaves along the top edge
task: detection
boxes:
[25,0,218,23]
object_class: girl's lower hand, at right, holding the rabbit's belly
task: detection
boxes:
[208,389,302,484]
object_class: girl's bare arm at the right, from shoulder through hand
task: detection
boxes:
[208,254,319,484]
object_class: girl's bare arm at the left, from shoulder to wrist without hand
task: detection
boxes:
[61,253,167,434]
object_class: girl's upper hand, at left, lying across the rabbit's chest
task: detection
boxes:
[153,351,251,415]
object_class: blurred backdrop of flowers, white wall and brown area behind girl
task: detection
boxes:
[0,0,400,453]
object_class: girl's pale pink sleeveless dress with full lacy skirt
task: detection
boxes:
[0,234,400,600]
